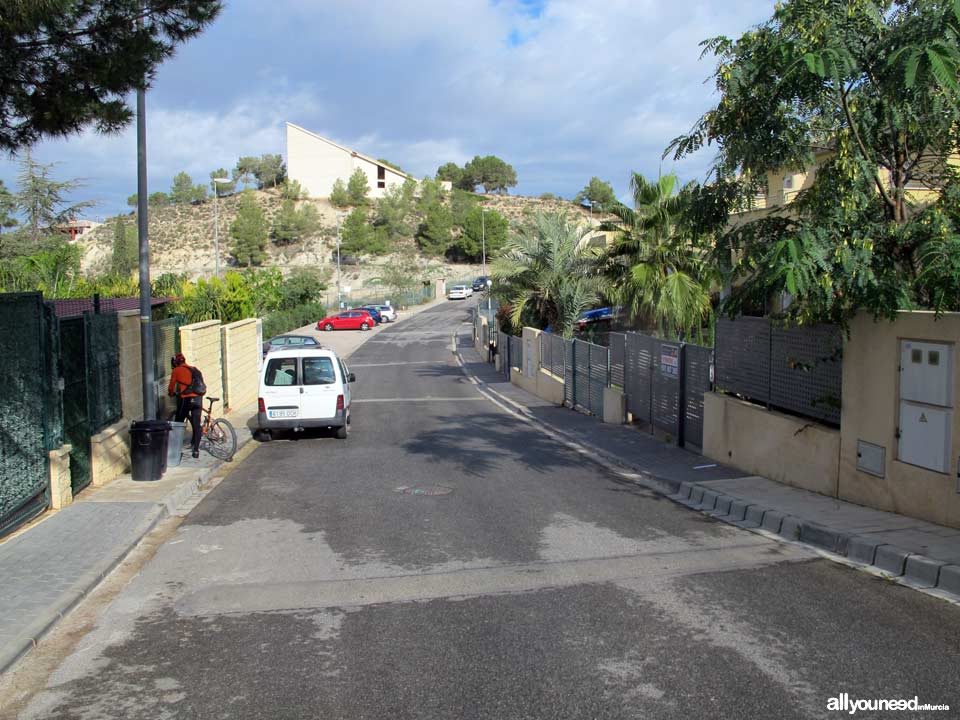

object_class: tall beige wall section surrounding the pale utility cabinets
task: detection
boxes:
[839,312,960,527]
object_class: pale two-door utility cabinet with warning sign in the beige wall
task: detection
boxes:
[897,340,953,473]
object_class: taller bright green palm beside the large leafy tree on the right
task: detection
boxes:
[605,173,713,337]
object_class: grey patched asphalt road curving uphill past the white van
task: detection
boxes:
[7,301,960,720]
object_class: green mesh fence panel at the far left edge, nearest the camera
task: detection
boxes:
[0,293,51,534]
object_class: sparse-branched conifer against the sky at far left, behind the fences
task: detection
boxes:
[14,150,93,254]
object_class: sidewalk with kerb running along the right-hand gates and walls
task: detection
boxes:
[457,332,960,602]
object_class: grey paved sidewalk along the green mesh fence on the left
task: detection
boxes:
[0,406,256,673]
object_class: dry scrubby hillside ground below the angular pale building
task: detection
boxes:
[82,190,608,288]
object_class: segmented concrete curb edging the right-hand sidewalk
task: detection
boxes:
[454,334,960,602]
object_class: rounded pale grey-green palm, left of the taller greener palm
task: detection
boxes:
[491,213,605,338]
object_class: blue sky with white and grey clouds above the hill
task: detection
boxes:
[0,0,774,217]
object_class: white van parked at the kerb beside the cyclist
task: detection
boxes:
[257,346,356,439]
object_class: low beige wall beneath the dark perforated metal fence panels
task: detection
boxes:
[703,393,846,496]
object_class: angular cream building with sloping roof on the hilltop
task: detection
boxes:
[287,122,410,198]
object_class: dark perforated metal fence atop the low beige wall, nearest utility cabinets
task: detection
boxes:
[716,317,843,425]
